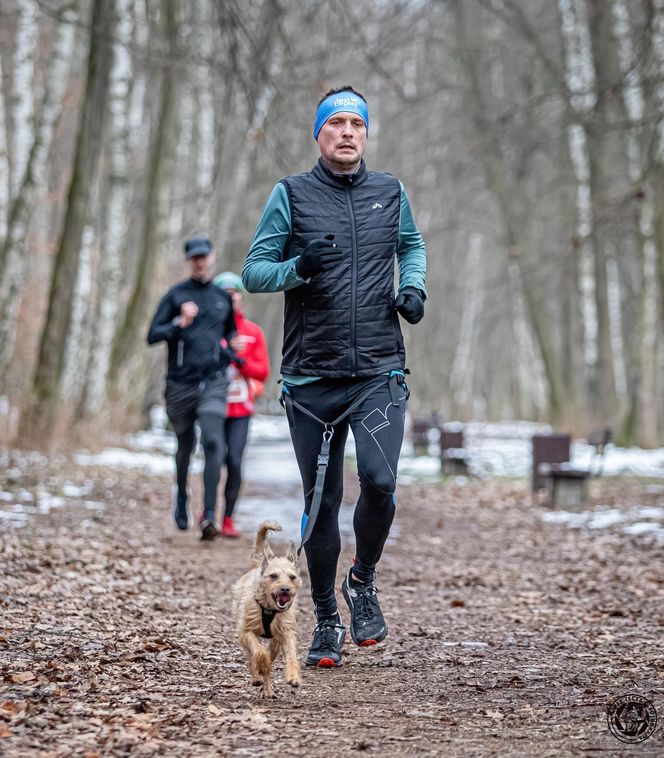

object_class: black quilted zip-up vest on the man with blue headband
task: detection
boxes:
[281,159,406,377]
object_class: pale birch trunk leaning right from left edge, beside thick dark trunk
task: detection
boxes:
[0,4,76,386]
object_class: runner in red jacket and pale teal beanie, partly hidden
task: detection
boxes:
[214,271,270,538]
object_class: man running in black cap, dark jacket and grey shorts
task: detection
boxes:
[148,237,236,540]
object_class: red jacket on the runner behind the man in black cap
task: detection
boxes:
[227,311,270,418]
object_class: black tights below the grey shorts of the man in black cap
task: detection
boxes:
[175,413,224,521]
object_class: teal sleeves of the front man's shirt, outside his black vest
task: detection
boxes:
[242,182,426,297]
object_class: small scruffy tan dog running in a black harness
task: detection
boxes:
[233,521,301,698]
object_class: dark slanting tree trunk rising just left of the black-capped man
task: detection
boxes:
[109,0,179,395]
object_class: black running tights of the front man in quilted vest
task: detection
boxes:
[288,376,406,618]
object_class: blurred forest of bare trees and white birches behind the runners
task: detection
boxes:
[0,0,664,446]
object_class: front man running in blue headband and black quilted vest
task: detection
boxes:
[242,86,426,667]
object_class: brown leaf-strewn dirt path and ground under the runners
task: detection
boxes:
[0,457,664,758]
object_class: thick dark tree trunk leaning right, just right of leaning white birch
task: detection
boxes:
[26,0,115,443]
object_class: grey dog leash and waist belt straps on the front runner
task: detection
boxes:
[279,371,409,557]
